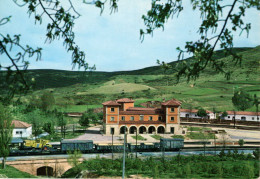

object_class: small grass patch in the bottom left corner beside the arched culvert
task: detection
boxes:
[0,165,37,178]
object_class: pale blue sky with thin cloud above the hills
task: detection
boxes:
[0,0,260,71]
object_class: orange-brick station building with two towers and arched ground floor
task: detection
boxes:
[102,98,181,135]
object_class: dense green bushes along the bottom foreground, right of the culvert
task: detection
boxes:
[64,151,259,178]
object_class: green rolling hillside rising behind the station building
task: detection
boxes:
[2,46,260,111]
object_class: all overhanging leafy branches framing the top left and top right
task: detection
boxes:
[0,0,260,98]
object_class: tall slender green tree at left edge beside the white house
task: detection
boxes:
[0,103,13,169]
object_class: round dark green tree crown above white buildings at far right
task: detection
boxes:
[232,90,253,111]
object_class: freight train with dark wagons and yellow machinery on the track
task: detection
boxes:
[9,138,184,156]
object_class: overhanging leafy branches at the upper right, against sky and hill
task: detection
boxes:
[140,0,260,80]
